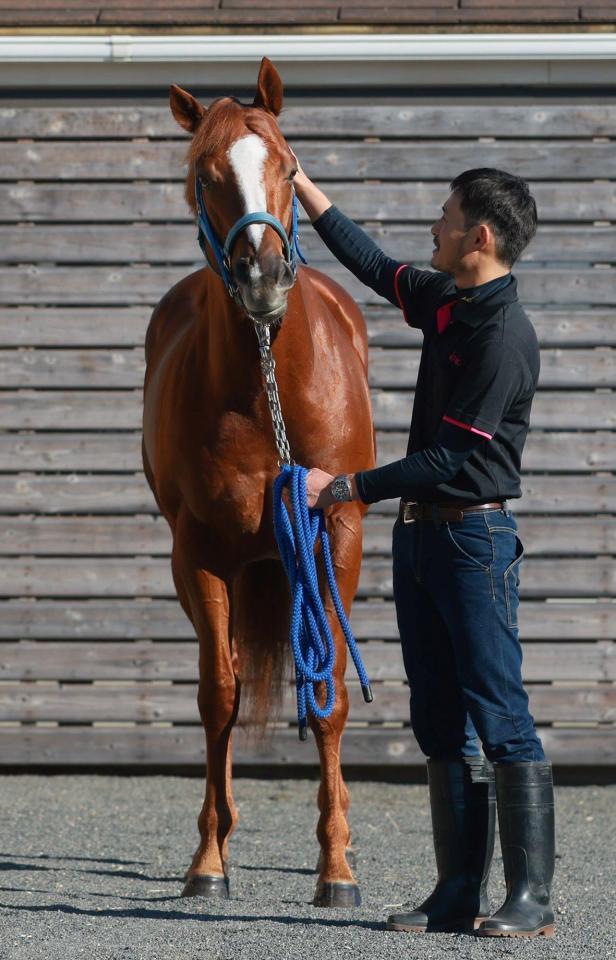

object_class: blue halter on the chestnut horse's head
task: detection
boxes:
[195,173,307,300]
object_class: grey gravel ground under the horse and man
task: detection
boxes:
[0,776,616,960]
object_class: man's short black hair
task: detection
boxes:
[451,167,537,266]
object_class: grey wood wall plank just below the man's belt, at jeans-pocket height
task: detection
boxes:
[0,515,616,557]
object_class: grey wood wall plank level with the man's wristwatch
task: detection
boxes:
[0,473,616,516]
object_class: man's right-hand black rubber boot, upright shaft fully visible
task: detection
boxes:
[477,762,554,937]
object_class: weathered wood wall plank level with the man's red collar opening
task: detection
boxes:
[0,305,616,349]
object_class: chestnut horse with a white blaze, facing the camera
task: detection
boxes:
[143,59,374,906]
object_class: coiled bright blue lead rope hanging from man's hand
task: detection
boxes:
[274,464,372,740]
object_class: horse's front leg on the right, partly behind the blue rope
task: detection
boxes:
[311,505,362,907]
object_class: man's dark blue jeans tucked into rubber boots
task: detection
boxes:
[393,510,545,762]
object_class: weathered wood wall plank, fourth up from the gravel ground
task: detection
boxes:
[0,598,616,640]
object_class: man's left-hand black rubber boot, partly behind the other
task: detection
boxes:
[387,757,496,933]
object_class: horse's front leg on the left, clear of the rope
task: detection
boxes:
[182,552,240,898]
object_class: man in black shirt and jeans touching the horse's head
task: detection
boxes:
[294,164,554,937]
